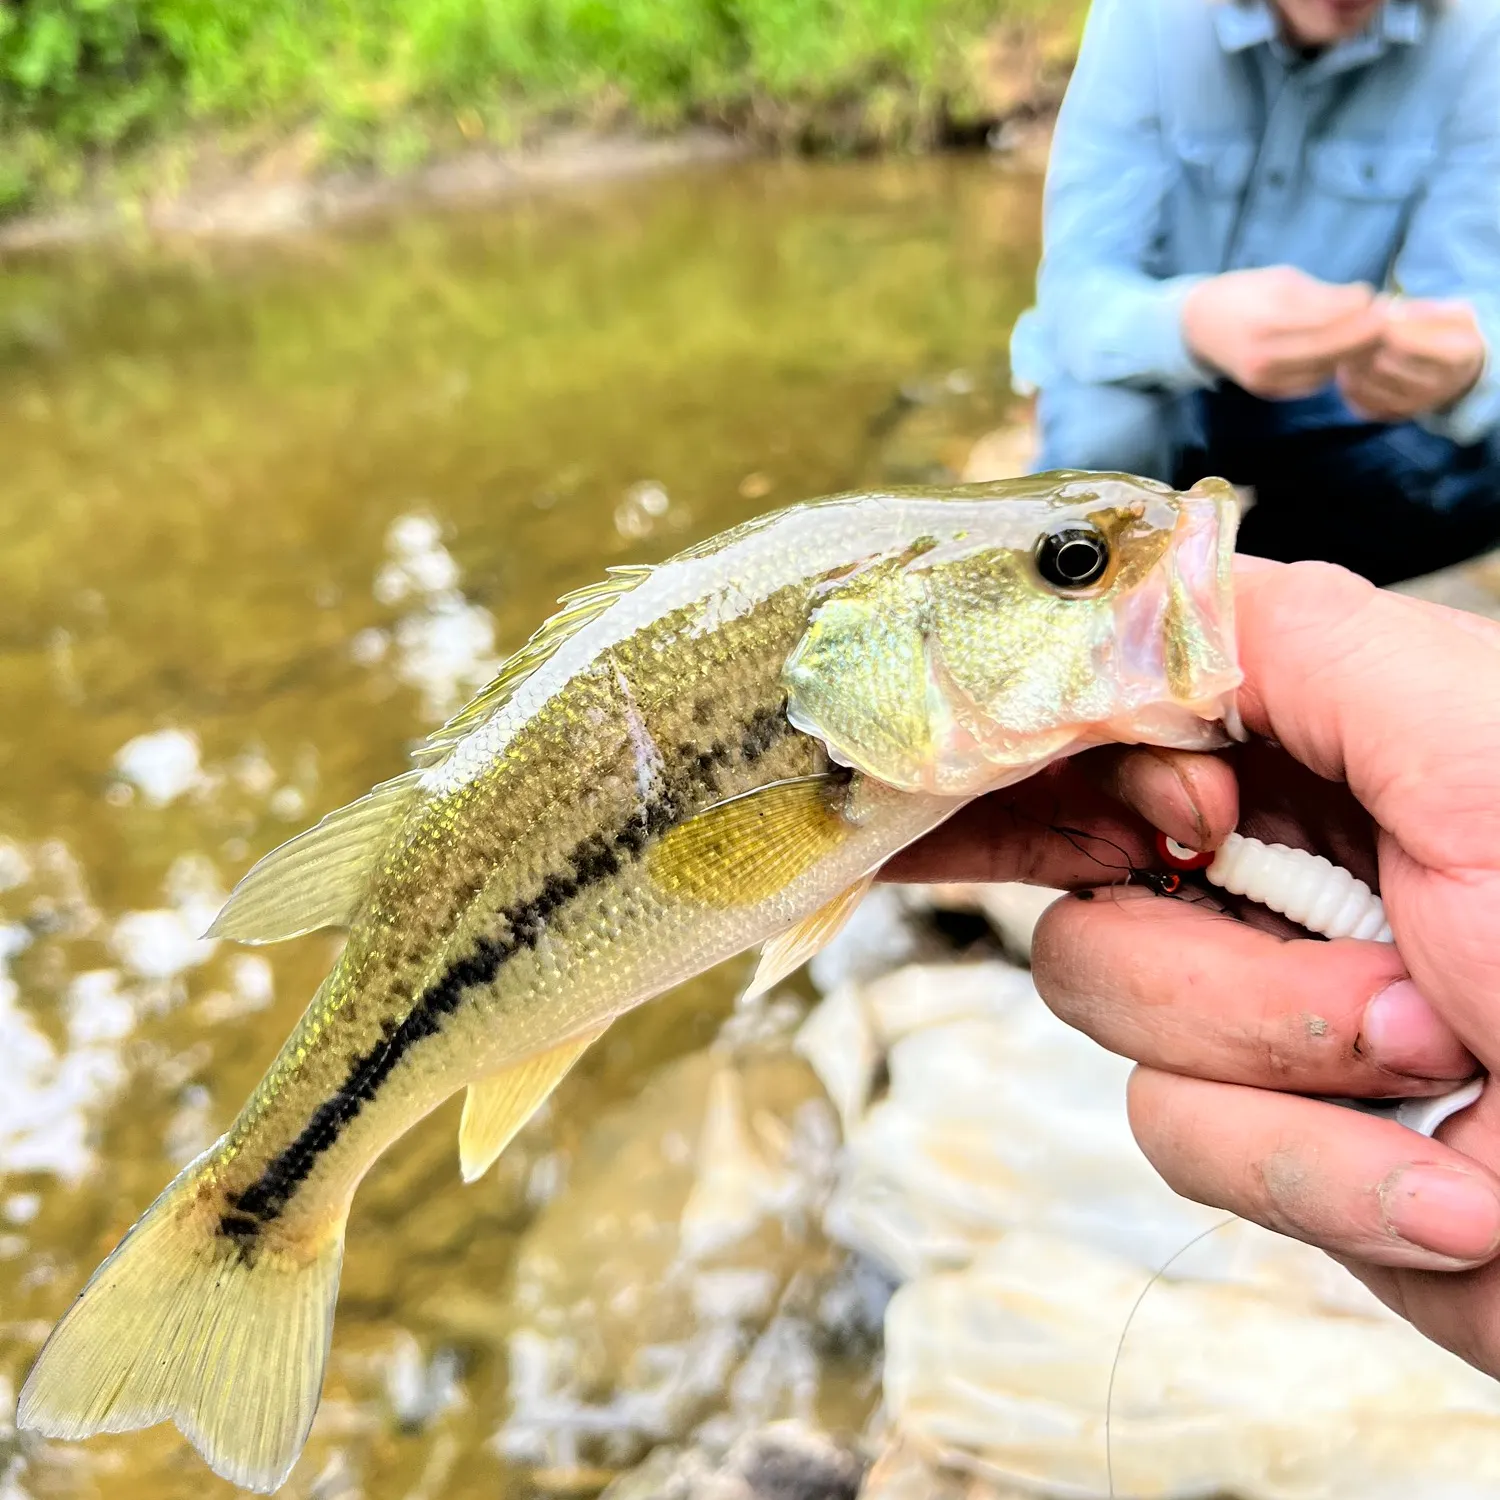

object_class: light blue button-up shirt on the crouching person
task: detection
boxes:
[1011,0,1500,444]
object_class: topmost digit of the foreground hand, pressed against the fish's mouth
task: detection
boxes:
[1236,563,1500,1071]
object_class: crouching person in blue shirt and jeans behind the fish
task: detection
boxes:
[1011,0,1500,584]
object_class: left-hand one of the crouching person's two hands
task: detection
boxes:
[1182,266,1385,401]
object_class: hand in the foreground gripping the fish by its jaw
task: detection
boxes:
[890,564,1500,1374]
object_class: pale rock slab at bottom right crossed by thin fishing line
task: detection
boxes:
[885,1233,1500,1500]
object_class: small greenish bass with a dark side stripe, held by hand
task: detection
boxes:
[18,471,1242,1493]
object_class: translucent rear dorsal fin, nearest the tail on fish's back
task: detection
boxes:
[204,771,422,944]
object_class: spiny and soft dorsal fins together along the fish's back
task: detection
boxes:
[207,567,651,944]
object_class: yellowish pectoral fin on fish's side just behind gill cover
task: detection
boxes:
[648,776,854,908]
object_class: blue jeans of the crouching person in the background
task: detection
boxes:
[1037,383,1500,584]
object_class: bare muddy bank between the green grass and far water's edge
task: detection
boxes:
[0,8,1077,255]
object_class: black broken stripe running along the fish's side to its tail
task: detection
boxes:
[219,708,794,1251]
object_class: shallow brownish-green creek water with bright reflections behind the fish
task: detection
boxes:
[0,162,1037,1500]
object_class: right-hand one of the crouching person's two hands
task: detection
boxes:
[1338,299,1485,422]
